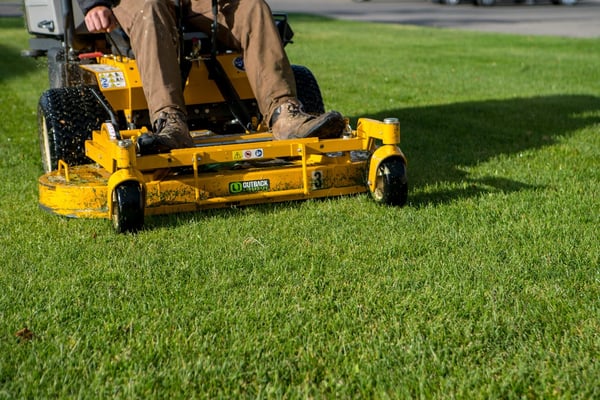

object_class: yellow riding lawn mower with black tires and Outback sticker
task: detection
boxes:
[25,0,408,232]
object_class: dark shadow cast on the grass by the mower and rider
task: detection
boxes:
[149,95,600,227]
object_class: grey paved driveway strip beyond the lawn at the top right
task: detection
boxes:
[267,0,600,37]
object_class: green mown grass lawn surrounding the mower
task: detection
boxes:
[0,15,600,399]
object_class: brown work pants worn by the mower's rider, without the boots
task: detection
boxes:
[113,0,296,121]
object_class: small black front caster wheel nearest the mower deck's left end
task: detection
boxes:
[111,181,144,233]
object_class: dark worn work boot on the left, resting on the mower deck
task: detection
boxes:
[137,109,194,155]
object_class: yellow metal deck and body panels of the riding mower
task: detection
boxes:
[39,54,406,219]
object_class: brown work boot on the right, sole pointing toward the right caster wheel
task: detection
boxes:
[271,100,346,140]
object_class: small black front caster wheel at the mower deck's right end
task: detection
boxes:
[367,157,408,206]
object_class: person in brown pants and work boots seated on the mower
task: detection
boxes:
[79,0,344,154]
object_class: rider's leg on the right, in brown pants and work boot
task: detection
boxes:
[184,0,345,139]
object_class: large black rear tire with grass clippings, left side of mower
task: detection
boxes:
[38,86,109,172]
